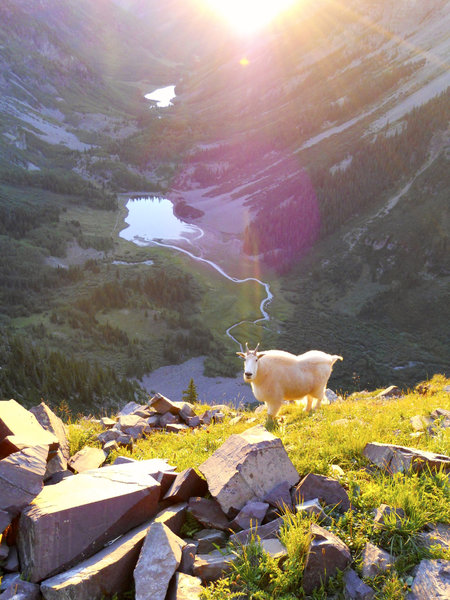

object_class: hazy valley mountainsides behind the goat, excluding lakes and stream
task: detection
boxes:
[0,0,450,407]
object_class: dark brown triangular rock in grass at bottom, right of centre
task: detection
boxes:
[302,523,352,594]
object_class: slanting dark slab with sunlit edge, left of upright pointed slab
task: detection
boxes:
[41,521,153,600]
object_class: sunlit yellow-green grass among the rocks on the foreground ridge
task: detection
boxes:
[70,375,450,600]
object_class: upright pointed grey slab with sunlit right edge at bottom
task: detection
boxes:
[134,523,184,600]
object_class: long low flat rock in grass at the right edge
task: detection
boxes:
[363,442,450,473]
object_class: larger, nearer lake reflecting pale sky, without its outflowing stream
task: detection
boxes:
[120,196,203,246]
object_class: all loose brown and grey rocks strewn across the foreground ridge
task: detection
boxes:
[0,394,450,600]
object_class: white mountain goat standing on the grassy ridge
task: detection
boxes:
[236,344,343,418]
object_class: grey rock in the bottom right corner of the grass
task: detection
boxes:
[408,559,450,600]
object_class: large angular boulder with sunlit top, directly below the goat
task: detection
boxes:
[199,426,299,514]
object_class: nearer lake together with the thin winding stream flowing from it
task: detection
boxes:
[120,197,273,350]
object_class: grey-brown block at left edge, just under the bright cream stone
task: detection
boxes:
[0,442,48,520]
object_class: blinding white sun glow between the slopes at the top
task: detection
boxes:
[206,0,298,35]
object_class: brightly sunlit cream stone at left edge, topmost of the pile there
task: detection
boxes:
[0,400,59,460]
